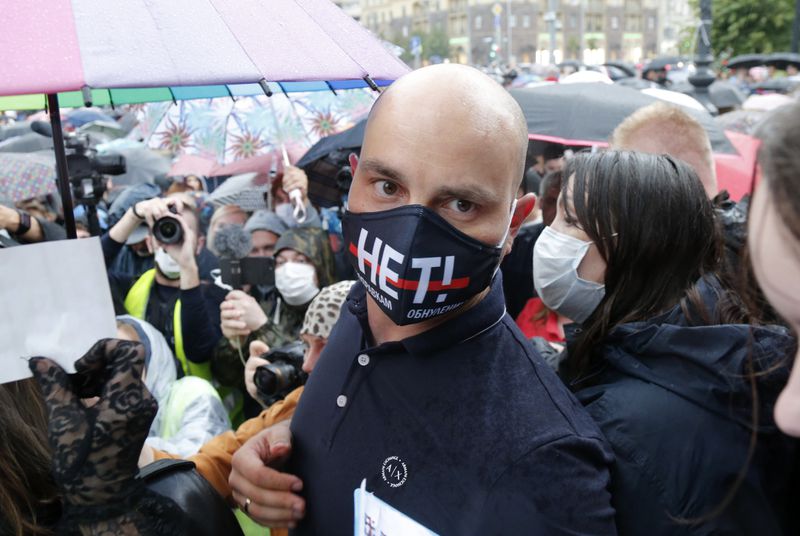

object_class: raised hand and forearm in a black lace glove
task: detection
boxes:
[29,339,182,536]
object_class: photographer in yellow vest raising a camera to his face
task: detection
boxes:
[102,198,223,379]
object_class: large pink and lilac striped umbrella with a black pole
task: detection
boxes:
[0,0,408,237]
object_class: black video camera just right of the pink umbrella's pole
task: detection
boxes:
[65,136,126,206]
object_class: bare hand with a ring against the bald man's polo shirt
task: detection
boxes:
[233,420,306,528]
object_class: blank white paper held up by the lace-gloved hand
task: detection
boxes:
[0,238,117,383]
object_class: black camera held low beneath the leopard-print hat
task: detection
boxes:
[253,341,308,406]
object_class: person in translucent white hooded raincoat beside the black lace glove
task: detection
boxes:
[117,315,231,457]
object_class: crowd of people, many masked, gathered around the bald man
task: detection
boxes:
[0,65,800,535]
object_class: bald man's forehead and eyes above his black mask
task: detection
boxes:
[349,97,520,255]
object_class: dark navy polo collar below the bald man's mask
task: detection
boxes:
[347,271,506,356]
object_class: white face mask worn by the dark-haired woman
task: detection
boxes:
[533,227,606,323]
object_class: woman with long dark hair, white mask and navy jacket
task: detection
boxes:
[534,151,795,535]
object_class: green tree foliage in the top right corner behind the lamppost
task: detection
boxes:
[692,0,795,56]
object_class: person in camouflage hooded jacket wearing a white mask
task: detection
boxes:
[212,227,335,415]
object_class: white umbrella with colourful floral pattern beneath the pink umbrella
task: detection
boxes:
[130,89,376,164]
